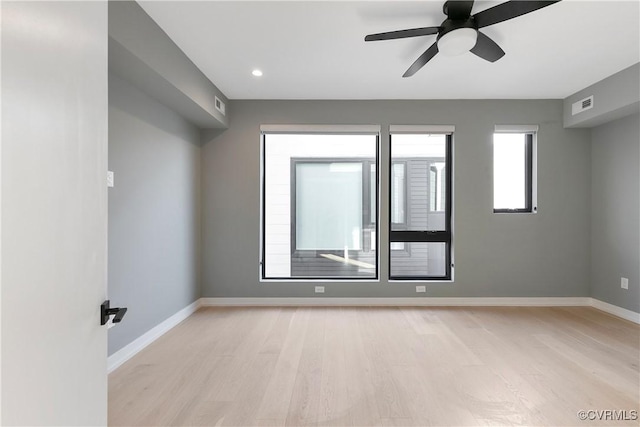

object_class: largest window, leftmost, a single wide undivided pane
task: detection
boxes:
[261,129,378,279]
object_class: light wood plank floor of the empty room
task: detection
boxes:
[109,307,640,426]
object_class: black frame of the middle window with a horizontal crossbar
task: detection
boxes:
[387,130,454,282]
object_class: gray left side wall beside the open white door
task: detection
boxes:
[108,75,201,354]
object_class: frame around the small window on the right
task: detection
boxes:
[491,126,538,214]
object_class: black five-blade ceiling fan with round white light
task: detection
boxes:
[364,0,560,77]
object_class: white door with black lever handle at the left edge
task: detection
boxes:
[0,0,107,425]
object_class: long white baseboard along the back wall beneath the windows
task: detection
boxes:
[200,297,591,307]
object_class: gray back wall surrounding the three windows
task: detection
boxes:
[202,100,591,297]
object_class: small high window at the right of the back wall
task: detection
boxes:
[493,132,537,213]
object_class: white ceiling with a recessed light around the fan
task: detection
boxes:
[139,0,640,99]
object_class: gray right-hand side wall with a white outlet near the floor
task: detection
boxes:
[591,114,640,312]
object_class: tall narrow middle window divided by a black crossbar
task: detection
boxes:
[389,126,452,280]
